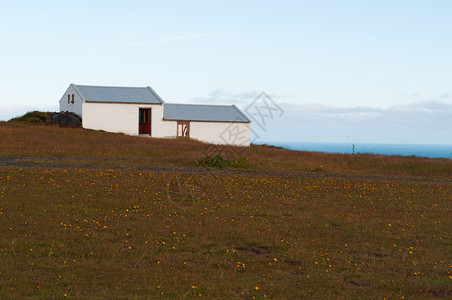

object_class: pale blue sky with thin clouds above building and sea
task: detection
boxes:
[0,0,452,144]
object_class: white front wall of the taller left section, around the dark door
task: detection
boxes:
[82,102,165,137]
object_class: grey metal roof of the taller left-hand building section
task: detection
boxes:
[72,84,164,104]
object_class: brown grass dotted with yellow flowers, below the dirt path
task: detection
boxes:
[0,168,452,299]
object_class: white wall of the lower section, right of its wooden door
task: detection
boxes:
[190,122,250,146]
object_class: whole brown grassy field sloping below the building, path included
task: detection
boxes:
[0,123,452,299]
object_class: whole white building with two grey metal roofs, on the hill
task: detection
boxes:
[60,84,251,146]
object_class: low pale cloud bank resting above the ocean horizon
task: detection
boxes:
[252,101,452,144]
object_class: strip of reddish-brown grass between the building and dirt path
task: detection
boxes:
[0,123,452,180]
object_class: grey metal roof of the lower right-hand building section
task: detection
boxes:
[163,103,251,123]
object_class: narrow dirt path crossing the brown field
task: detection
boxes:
[0,156,452,184]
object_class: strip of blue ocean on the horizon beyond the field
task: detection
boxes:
[256,142,452,159]
